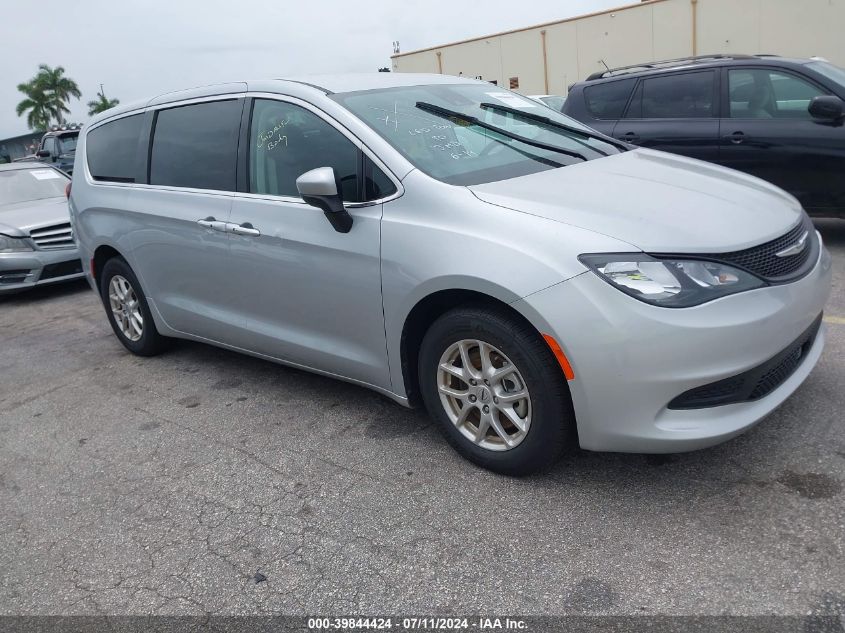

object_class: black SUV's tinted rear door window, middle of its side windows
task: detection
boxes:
[625,70,716,119]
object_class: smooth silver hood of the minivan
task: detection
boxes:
[469,149,802,253]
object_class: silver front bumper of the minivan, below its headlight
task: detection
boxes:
[514,237,831,453]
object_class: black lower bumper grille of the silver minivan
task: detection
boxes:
[669,315,822,409]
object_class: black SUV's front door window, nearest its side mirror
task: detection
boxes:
[728,69,825,119]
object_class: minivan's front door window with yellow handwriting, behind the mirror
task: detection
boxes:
[249,99,370,202]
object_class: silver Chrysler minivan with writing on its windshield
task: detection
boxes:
[70,73,831,474]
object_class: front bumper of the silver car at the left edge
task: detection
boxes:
[0,248,83,295]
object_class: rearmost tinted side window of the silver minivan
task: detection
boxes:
[85,114,144,182]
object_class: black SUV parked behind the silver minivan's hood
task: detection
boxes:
[563,55,845,217]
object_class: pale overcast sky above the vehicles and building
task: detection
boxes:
[0,0,620,138]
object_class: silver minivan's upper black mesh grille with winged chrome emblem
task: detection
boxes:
[705,216,816,280]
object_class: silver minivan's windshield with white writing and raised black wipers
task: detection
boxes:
[332,84,623,185]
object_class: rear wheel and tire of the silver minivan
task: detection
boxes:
[100,257,169,356]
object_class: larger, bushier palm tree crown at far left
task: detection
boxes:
[16,64,82,130]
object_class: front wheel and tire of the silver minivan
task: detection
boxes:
[418,307,575,475]
